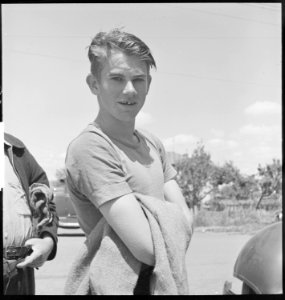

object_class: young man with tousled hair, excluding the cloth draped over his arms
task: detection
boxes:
[66,29,193,294]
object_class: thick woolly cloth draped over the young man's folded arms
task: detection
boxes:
[64,193,192,295]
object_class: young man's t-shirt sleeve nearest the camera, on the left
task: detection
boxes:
[65,132,132,208]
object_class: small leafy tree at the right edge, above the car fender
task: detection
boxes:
[256,159,282,209]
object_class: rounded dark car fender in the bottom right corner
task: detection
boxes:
[224,221,283,295]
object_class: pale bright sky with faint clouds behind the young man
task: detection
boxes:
[0,3,282,185]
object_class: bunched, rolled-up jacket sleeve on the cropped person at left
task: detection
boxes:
[29,183,53,236]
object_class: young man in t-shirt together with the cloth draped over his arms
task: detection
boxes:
[65,29,193,295]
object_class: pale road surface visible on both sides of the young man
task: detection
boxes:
[35,229,251,295]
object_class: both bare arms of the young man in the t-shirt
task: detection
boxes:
[99,180,191,266]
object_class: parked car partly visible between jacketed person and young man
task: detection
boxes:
[52,181,80,228]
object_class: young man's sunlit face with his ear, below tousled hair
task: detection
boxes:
[89,50,151,121]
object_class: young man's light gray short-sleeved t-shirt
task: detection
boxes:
[65,123,176,235]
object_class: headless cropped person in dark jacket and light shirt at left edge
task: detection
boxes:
[3,133,58,295]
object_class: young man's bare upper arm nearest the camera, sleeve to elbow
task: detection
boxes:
[99,194,155,266]
